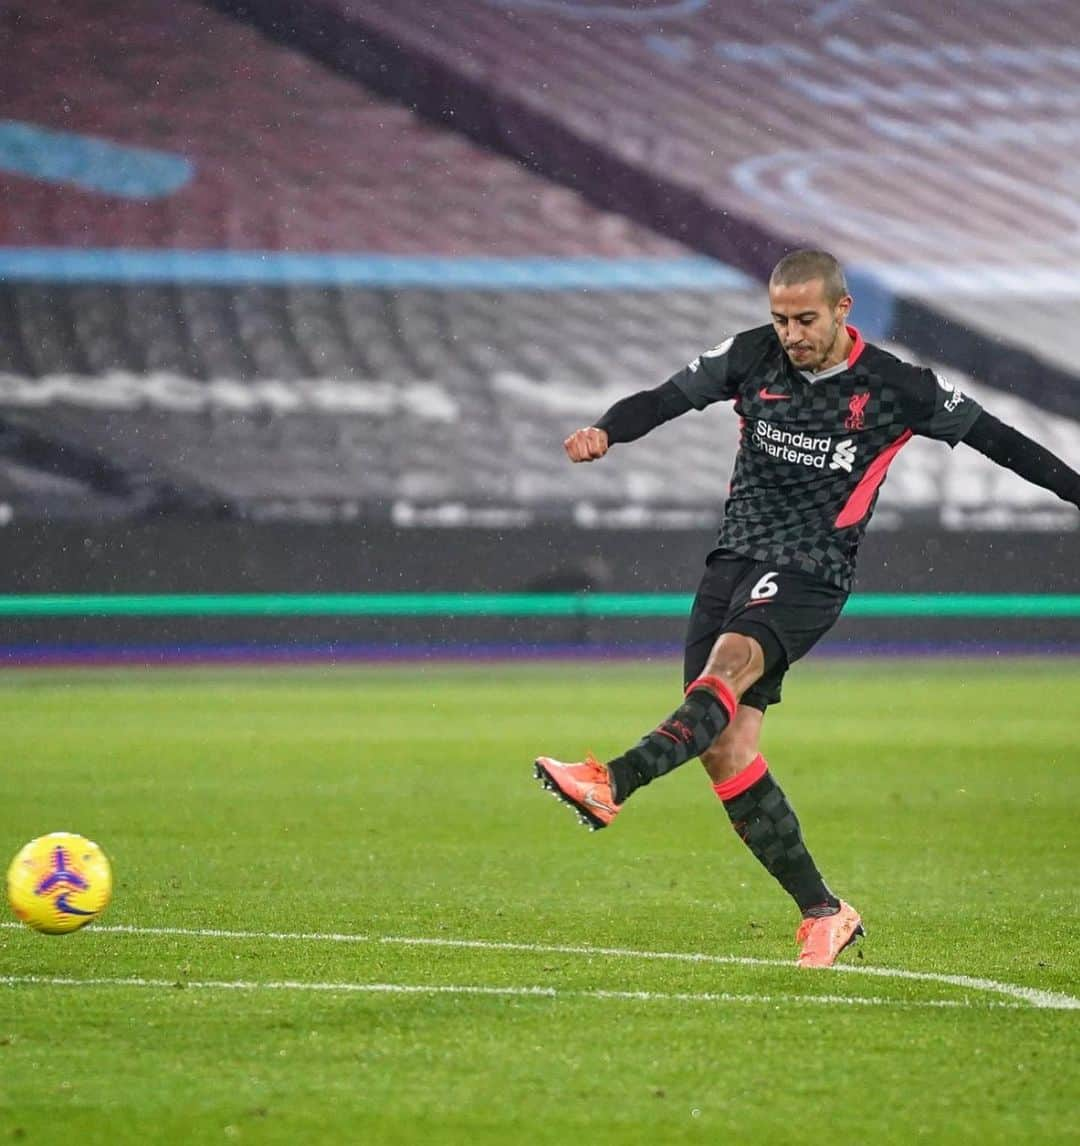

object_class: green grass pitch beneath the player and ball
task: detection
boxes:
[0,660,1080,1146]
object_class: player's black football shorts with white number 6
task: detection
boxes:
[682,549,847,712]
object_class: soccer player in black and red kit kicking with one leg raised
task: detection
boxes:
[535,251,1080,967]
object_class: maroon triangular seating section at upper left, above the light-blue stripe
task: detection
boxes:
[0,0,686,257]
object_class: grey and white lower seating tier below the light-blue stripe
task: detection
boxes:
[0,277,1080,525]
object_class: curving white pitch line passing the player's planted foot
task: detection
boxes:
[0,923,1080,1011]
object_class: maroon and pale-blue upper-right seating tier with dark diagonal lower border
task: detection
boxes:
[238,0,1080,417]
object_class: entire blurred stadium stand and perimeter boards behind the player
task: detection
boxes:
[0,0,1080,662]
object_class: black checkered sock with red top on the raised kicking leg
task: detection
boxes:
[608,676,738,803]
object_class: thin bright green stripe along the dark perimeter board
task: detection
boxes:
[0,592,1080,618]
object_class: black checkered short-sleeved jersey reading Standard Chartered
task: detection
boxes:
[670,325,980,589]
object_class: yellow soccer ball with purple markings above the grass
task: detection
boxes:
[8,832,112,935]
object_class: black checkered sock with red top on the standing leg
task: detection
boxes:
[713,754,840,916]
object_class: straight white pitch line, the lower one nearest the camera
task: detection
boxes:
[0,975,1026,1011]
